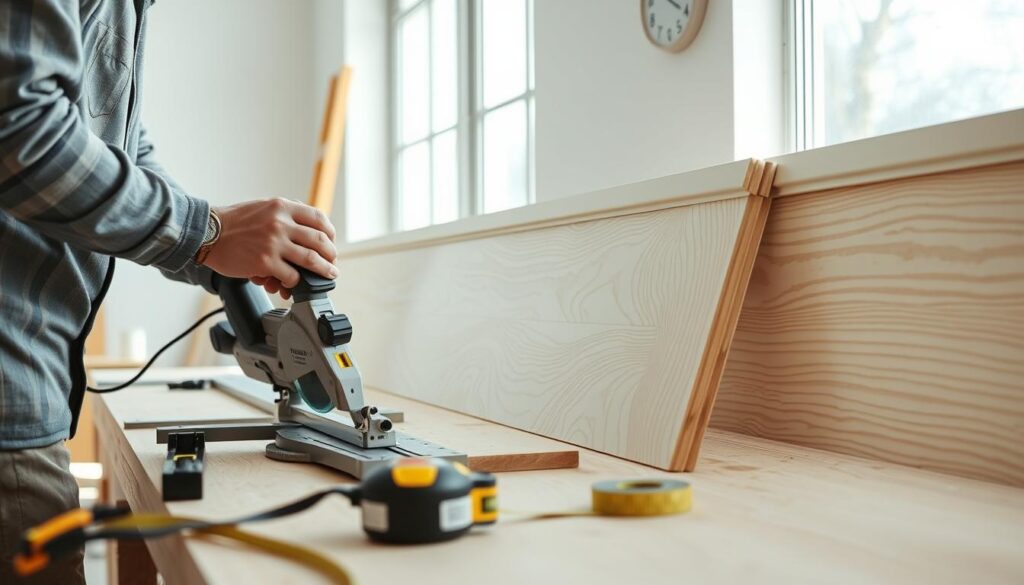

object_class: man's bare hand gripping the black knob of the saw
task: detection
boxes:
[203,199,338,298]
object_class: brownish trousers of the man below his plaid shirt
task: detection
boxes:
[0,442,85,585]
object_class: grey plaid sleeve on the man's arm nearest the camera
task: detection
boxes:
[0,0,209,273]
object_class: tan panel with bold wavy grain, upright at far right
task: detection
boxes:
[711,163,1024,486]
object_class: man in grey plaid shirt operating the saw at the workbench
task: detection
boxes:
[0,0,337,584]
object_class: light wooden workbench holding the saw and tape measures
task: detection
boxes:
[90,373,1024,585]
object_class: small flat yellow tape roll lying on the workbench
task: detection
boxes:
[591,479,693,516]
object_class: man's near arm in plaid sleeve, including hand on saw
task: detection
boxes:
[0,0,336,287]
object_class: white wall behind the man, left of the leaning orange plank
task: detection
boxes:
[104,0,323,364]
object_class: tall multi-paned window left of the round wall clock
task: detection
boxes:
[391,0,535,229]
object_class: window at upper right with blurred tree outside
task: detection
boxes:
[788,0,1024,150]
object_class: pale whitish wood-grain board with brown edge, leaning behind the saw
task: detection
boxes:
[333,161,774,470]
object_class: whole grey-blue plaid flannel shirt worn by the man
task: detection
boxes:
[0,0,209,449]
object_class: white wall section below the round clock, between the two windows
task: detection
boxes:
[535,0,734,201]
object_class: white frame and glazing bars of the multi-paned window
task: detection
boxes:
[387,0,536,233]
